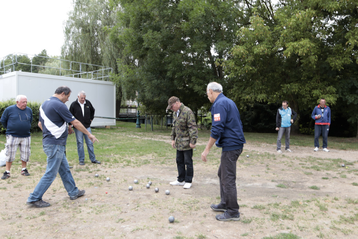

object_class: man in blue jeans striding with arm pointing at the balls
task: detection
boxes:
[27,86,98,207]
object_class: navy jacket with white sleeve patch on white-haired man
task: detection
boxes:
[210,93,246,151]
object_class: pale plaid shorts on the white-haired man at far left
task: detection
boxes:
[5,135,31,163]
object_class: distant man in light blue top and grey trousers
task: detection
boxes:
[276,100,297,153]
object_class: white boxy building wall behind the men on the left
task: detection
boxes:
[0,72,116,126]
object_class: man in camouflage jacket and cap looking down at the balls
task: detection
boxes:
[167,96,198,189]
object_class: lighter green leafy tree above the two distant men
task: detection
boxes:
[225,0,357,134]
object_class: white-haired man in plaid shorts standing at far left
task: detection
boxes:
[0,95,32,179]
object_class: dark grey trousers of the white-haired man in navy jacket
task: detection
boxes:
[218,149,243,215]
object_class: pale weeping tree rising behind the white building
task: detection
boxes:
[62,0,122,115]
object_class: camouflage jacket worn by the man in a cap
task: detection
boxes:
[171,103,198,151]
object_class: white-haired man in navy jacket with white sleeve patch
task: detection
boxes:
[201,82,246,221]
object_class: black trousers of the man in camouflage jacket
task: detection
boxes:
[177,149,194,183]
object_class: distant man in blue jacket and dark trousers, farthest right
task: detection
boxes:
[312,98,331,152]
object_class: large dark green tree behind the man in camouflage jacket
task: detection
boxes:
[112,0,242,114]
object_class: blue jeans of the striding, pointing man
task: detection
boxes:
[27,144,78,202]
